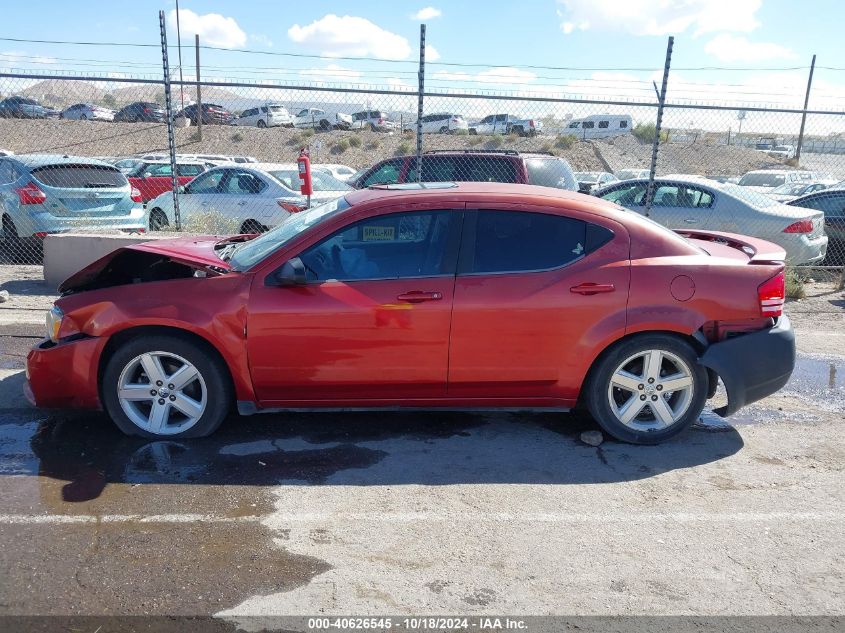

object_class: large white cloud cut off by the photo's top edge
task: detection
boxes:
[558,0,762,35]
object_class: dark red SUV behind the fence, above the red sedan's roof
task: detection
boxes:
[349,150,578,191]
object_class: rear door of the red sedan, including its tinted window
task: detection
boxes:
[448,204,629,406]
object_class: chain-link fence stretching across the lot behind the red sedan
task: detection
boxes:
[0,29,845,282]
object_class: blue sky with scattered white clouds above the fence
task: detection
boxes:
[0,0,845,131]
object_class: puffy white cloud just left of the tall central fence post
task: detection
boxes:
[288,13,411,59]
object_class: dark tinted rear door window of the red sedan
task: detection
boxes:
[464,211,587,273]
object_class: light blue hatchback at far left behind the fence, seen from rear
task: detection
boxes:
[0,154,146,260]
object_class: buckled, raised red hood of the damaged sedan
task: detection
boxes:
[58,235,237,293]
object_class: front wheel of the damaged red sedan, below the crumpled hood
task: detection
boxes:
[101,334,233,439]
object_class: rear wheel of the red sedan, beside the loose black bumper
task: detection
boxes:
[585,334,709,444]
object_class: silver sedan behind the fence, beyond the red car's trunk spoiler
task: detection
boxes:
[595,177,828,264]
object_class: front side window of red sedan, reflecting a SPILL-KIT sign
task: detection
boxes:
[299,211,453,282]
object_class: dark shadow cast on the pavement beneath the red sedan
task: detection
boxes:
[0,374,743,502]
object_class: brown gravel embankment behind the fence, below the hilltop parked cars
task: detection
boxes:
[0,119,782,175]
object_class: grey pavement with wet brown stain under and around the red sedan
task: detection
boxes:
[0,275,845,631]
